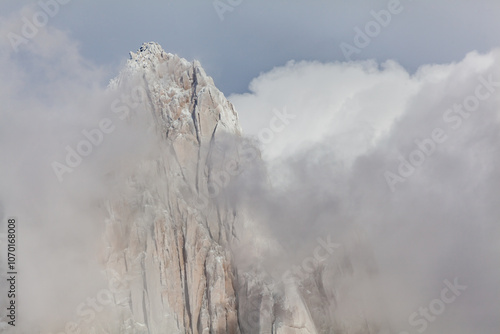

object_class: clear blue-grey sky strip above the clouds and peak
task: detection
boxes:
[0,0,500,95]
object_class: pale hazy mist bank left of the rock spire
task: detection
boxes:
[0,12,157,333]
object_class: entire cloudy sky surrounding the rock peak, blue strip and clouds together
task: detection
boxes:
[0,0,500,334]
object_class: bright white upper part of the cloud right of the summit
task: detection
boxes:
[229,61,421,162]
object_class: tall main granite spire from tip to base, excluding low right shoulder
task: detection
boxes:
[102,43,244,333]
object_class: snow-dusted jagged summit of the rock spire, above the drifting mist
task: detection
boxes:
[110,42,241,140]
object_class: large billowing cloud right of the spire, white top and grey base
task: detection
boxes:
[230,49,500,334]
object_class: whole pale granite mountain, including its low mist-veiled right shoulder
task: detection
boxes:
[94,43,382,334]
